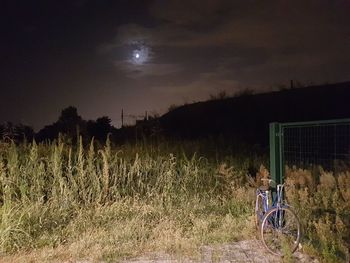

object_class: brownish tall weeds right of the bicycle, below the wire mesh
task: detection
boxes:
[286,167,350,262]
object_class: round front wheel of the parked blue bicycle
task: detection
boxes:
[261,207,300,256]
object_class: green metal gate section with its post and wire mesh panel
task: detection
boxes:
[270,119,350,184]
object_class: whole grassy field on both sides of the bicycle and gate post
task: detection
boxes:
[0,141,350,262]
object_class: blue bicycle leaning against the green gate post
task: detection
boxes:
[255,179,301,256]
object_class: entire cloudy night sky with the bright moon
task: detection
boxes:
[0,0,350,130]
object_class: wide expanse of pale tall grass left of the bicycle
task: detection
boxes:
[0,140,254,261]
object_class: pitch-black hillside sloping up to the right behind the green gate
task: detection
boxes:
[160,82,350,144]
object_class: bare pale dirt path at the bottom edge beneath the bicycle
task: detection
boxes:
[123,240,318,263]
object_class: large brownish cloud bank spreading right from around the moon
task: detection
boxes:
[100,0,350,97]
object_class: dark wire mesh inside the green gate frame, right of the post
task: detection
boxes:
[282,123,350,171]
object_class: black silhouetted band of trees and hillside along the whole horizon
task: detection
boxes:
[0,82,350,146]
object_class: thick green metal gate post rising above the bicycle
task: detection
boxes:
[270,122,284,184]
